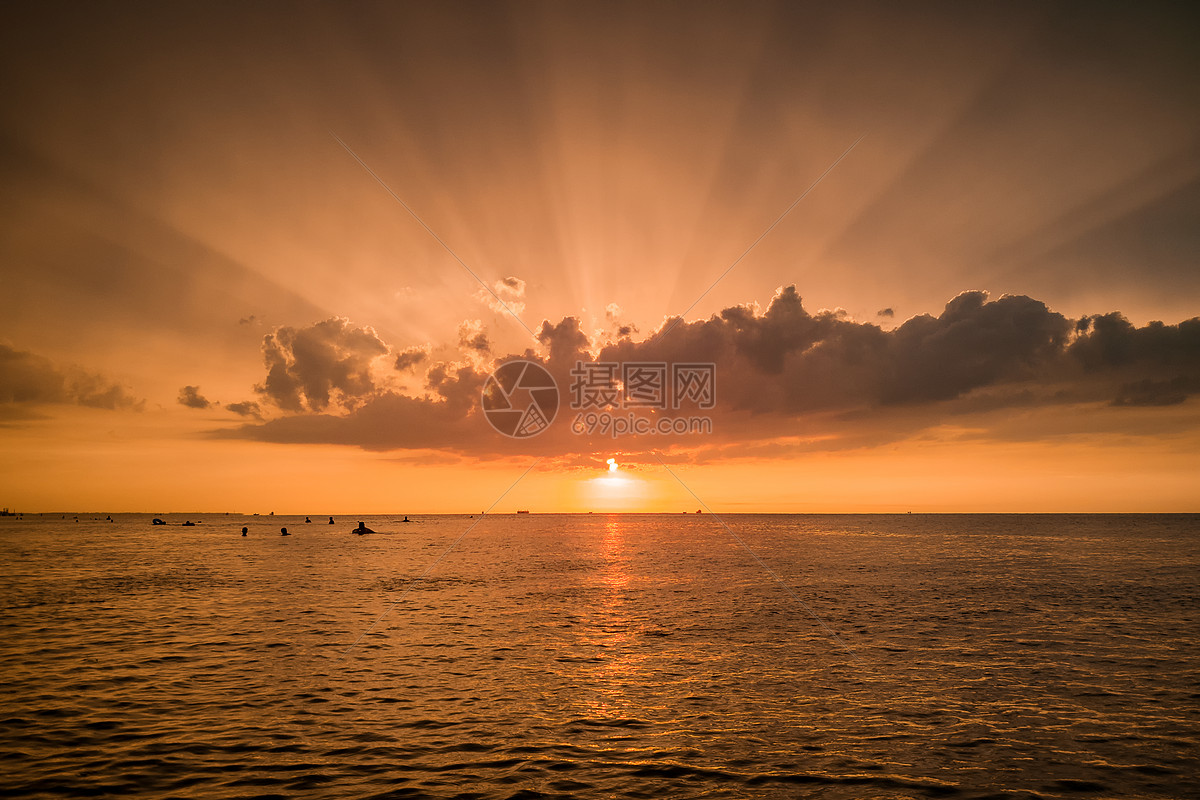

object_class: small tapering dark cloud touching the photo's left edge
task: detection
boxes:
[0,343,144,417]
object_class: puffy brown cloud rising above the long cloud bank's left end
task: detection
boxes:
[254,317,388,411]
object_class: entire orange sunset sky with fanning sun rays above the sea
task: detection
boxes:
[0,2,1200,515]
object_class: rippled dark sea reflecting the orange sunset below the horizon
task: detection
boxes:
[0,515,1200,799]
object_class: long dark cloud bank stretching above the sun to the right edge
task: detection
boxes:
[218,287,1200,456]
